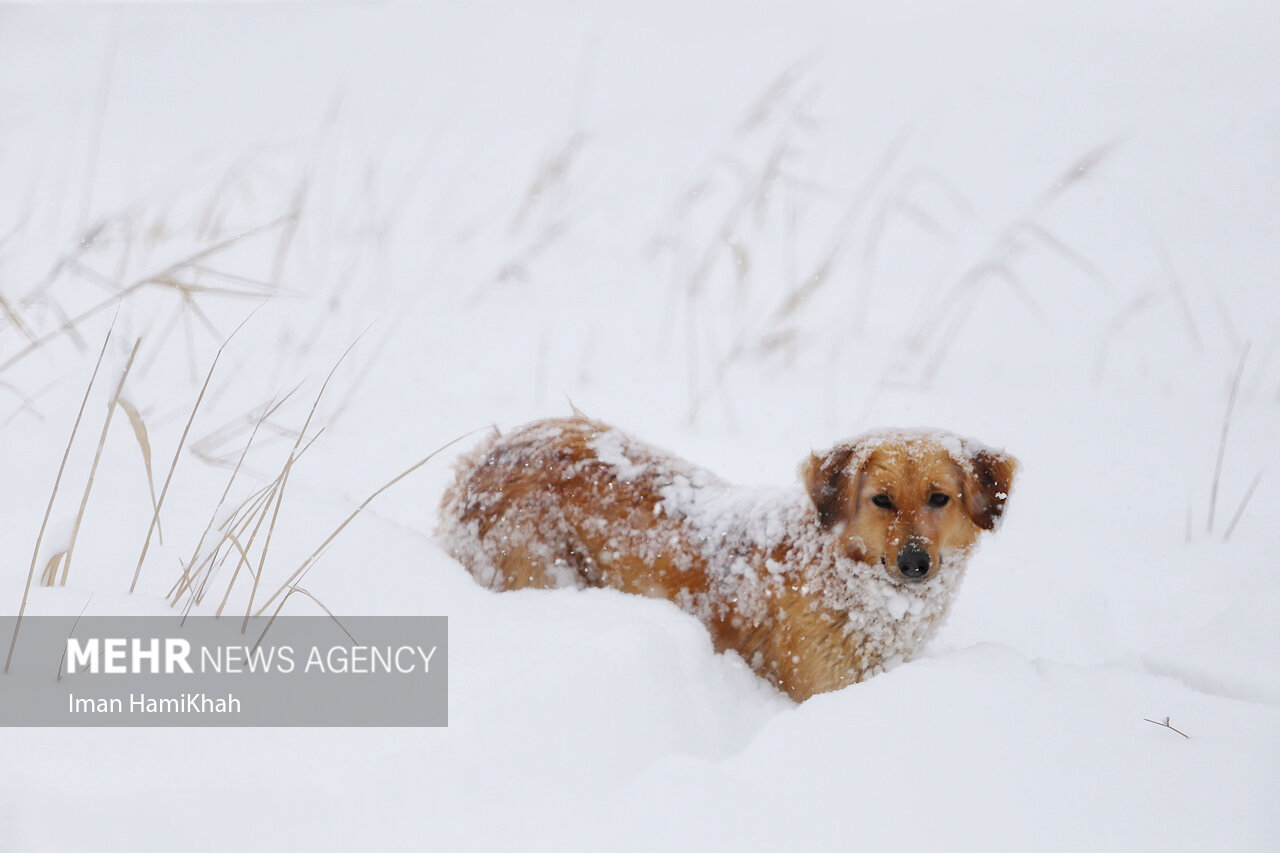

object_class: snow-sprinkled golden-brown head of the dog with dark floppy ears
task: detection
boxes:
[800,430,1018,581]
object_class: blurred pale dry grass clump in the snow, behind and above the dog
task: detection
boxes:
[649,63,1115,425]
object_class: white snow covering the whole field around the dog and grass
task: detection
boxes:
[0,0,1280,850]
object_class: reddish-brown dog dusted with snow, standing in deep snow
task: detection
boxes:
[436,416,1018,702]
